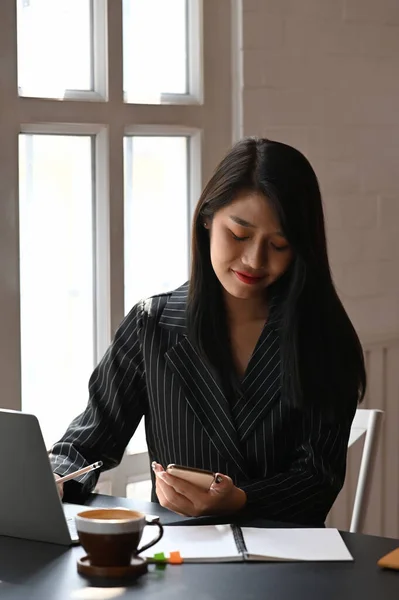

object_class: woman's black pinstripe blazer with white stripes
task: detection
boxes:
[51,284,356,524]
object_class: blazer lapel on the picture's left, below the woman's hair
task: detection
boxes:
[159,284,247,474]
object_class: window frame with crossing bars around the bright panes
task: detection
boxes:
[0,0,234,496]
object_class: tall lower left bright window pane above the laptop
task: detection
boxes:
[20,135,94,447]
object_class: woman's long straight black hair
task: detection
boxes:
[187,137,366,410]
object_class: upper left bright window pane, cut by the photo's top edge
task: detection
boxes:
[17,0,92,98]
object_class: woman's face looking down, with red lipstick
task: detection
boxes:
[205,192,293,299]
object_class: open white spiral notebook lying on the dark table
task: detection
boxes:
[140,525,353,563]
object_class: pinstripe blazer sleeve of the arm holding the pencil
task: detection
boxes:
[50,304,146,501]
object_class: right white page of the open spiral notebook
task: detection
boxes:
[242,527,353,561]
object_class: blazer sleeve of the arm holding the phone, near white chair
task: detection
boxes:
[238,405,356,524]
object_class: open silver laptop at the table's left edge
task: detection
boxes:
[0,409,82,546]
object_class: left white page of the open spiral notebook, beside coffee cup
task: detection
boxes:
[140,525,240,562]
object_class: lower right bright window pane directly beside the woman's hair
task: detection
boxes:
[125,136,189,454]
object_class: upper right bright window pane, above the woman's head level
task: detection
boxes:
[123,0,188,104]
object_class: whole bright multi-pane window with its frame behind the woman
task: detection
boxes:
[0,0,233,494]
